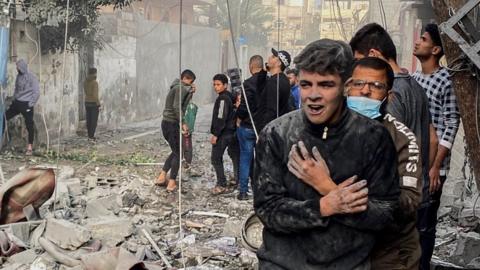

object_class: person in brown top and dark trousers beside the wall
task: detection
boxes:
[83,68,100,142]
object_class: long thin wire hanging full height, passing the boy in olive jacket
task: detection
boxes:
[178,0,185,268]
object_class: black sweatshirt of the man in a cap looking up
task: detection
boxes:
[255,73,290,132]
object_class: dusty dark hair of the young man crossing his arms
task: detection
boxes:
[294,39,353,82]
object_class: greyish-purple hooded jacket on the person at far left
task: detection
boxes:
[13,59,40,108]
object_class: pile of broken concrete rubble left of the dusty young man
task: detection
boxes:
[0,123,258,270]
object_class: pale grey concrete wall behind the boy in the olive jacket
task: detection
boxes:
[95,11,220,130]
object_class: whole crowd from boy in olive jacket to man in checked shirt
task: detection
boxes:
[157,23,460,270]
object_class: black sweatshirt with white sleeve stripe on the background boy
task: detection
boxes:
[210,90,235,137]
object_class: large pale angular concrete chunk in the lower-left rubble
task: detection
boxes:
[44,219,92,250]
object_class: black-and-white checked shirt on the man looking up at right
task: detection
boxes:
[413,67,460,176]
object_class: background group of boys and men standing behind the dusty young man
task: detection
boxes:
[156,49,299,200]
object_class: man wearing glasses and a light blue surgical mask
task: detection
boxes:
[346,57,422,269]
